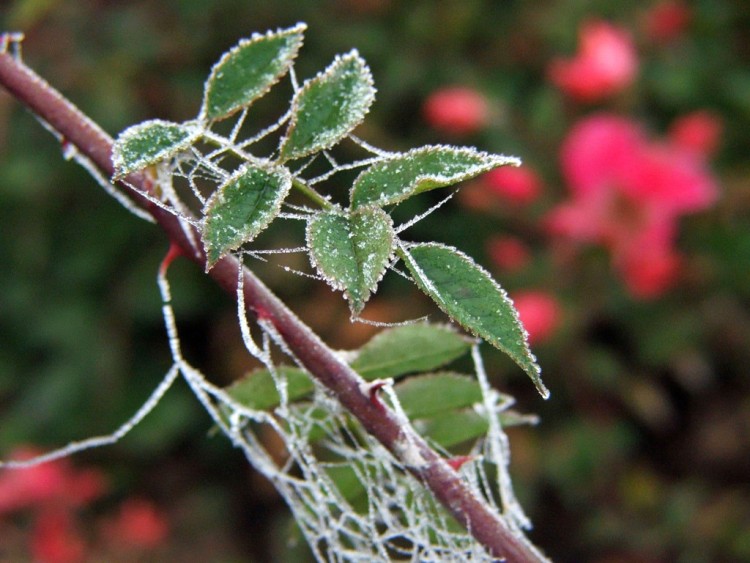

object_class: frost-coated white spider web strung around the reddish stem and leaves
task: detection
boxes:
[0,48,542,561]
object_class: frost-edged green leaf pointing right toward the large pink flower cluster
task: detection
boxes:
[351,146,520,209]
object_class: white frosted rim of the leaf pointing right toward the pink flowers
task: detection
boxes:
[350,145,521,209]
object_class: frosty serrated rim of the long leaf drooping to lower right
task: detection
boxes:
[401,242,550,399]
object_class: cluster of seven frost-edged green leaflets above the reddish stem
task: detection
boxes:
[113,24,548,396]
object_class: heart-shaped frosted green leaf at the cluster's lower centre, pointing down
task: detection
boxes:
[307,207,395,315]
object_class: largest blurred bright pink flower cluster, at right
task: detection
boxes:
[547,115,717,298]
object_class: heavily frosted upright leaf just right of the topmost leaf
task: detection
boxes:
[280,51,375,161]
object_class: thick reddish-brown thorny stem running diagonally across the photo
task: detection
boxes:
[0,46,543,562]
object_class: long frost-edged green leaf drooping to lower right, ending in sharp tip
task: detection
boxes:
[402,243,549,398]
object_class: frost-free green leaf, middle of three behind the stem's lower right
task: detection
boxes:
[393,372,482,419]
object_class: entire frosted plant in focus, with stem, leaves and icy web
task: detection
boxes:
[0,24,548,561]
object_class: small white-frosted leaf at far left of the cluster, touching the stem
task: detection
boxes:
[112,119,201,178]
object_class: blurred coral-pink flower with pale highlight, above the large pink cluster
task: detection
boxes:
[549,21,638,102]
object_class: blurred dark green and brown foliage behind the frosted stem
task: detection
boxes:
[0,0,750,563]
